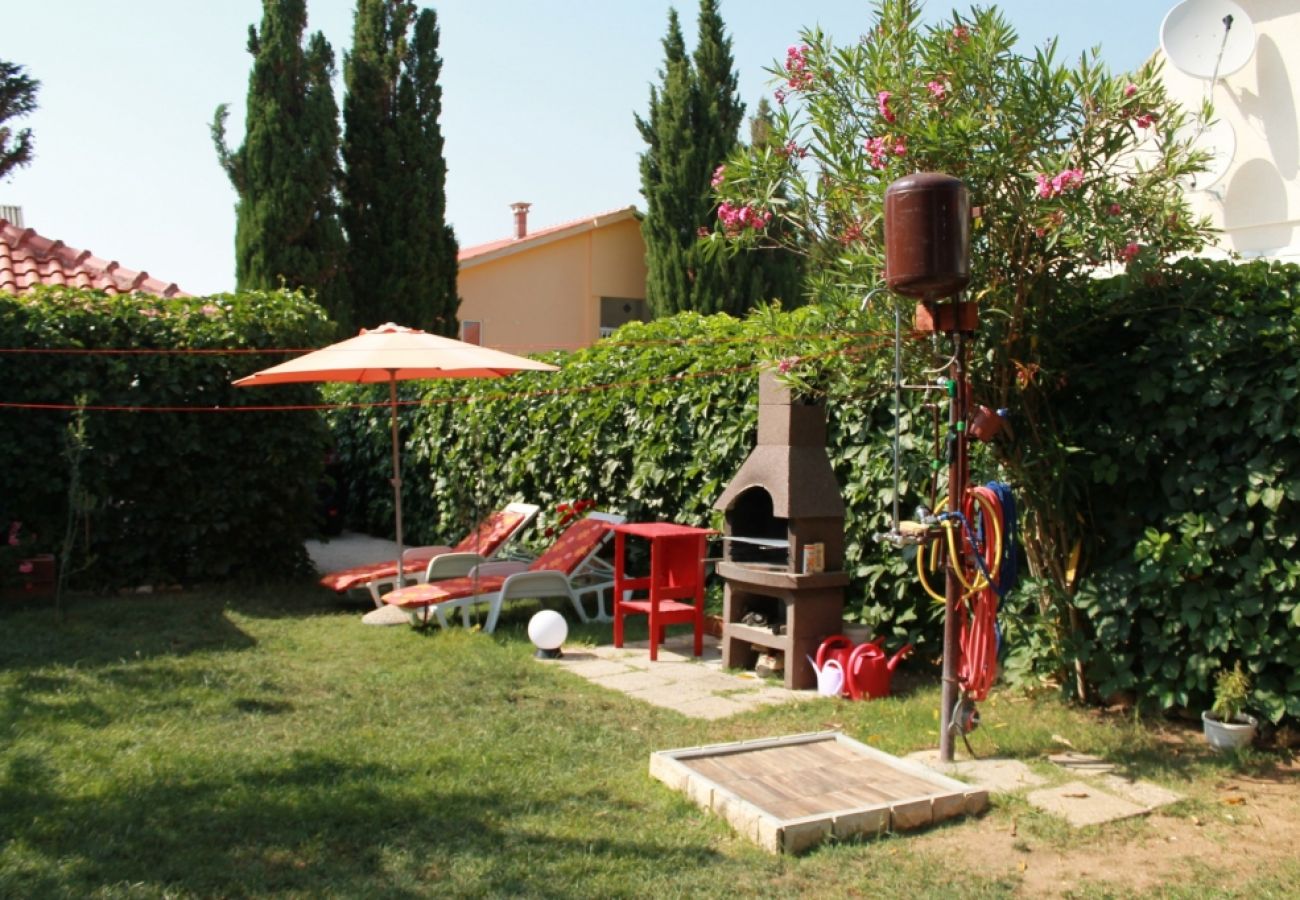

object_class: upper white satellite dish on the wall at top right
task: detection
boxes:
[1160,0,1255,79]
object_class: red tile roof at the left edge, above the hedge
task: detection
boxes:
[0,218,190,297]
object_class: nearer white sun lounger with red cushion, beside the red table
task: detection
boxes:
[384,512,624,633]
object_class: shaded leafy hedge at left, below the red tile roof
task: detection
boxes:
[0,289,330,587]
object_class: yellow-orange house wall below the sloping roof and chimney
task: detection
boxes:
[459,217,646,354]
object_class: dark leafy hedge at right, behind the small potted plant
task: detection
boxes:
[1056,260,1300,721]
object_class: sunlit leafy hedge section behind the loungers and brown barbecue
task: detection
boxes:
[328,307,937,641]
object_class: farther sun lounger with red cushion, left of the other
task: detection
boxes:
[321,503,538,607]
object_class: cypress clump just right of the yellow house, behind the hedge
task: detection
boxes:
[637,0,798,316]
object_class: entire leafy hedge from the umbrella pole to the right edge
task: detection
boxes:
[329,261,1300,719]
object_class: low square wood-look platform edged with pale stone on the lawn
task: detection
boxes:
[650,731,988,853]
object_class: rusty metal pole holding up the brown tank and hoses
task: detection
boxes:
[939,321,969,762]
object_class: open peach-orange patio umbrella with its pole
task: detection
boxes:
[234,323,556,587]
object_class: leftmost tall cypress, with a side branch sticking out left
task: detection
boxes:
[212,0,351,324]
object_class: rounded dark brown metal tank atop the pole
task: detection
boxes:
[885,172,971,300]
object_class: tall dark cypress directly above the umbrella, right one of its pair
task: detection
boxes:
[343,0,459,336]
